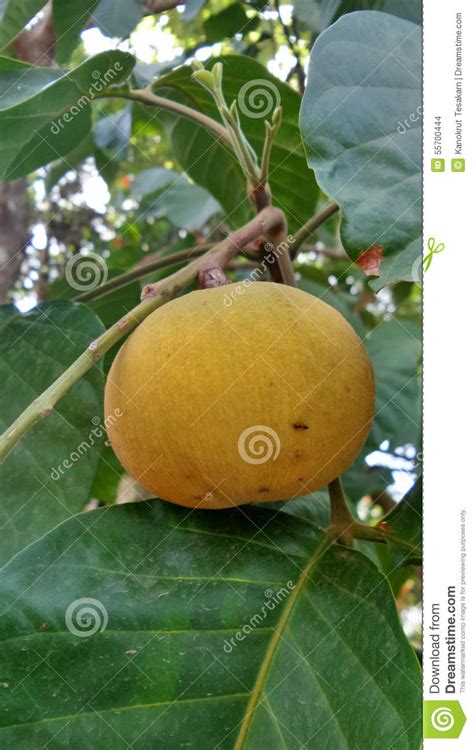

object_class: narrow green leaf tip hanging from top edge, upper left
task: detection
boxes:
[52,0,99,65]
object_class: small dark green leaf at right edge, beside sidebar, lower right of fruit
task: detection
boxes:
[383,479,422,568]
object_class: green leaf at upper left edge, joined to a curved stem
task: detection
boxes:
[0,51,135,180]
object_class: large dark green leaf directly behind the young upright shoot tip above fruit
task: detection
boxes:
[157,55,318,230]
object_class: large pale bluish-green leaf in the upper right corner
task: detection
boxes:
[301,12,421,289]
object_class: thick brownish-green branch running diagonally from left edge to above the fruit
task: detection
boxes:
[0,206,286,462]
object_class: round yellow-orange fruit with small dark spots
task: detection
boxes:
[105,282,374,508]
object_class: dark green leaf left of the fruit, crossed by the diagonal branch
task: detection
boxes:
[0,300,105,562]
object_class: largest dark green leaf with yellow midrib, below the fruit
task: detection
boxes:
[0,500,421,750]
